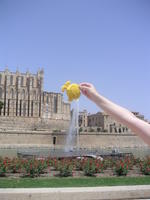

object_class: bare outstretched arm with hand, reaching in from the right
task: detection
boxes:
[80,83,150,145]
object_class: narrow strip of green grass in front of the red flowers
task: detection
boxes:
[0,176,150,188]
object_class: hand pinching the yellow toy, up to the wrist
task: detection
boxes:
[79,83,98,102]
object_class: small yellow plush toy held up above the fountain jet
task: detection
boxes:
[62,81,80,101]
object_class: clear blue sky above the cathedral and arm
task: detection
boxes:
[0,0,150,119]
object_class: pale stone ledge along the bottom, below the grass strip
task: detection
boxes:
[0,185,150,200]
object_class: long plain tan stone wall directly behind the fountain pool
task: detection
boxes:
[0,131,148,148]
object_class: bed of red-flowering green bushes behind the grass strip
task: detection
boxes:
[0,156,150,178]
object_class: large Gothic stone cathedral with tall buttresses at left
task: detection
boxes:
[0,69,70,120]
